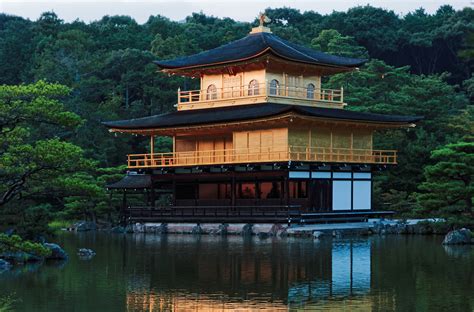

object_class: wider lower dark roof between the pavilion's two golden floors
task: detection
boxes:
[103,103,423,130]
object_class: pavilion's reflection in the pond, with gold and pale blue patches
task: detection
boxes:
[127,236,371,311]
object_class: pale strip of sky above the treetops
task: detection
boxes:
[0,0,474,23]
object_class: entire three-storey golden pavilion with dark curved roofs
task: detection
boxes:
[104,18,421,223]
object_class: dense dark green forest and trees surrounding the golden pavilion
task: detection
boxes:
[0,6,474,232]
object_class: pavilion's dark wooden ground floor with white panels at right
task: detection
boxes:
[108,163,392,223]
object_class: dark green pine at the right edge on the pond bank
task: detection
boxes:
[418,137,474,218]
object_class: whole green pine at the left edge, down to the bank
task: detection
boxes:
[0,81,105,238]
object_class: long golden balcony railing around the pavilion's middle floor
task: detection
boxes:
[128,146,397,168]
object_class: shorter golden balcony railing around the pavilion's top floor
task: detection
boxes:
[178,83,344,105]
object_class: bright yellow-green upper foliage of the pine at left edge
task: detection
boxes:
[0,81,86,207]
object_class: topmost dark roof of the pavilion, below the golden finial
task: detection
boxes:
[155,32,366,69]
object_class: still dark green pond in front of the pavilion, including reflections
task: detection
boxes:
[0,233,474,311]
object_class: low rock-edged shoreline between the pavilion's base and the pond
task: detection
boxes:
[63,218,460,238]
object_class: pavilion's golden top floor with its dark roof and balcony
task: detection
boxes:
[155,18,366,110]
